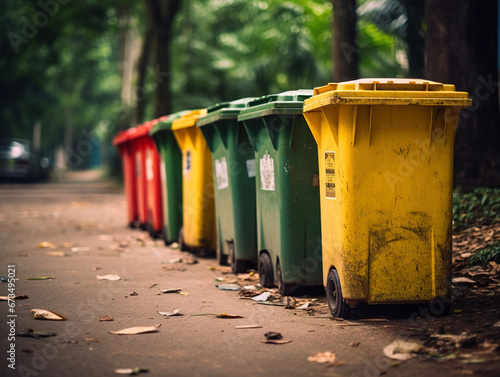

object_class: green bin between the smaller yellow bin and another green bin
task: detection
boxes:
[196,98,257,273]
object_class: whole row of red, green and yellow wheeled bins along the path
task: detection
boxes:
[114,79,472,317]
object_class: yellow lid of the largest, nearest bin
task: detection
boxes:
[304,78,472,112]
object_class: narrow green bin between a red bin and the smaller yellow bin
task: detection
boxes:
[149,111,189,245]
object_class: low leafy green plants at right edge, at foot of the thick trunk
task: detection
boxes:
[453,188,500,231]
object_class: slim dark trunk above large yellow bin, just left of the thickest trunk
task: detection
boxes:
[404,0,425,78]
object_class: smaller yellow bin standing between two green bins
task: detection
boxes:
[172,109,216,252]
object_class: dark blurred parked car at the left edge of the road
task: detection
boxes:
[0,138,50,180]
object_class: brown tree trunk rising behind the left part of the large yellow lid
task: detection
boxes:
[332,0,360,82]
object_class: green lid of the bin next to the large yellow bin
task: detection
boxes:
[238,89,313,121]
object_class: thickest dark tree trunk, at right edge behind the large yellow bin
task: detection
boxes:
[425,0,500,188]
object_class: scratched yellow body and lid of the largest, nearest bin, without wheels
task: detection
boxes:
[304,79,472,304]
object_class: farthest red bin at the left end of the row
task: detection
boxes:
[113,128,139,228]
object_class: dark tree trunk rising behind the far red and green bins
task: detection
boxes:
[145,0,180,118]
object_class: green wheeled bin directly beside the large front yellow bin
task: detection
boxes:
[238,90,322,295]
